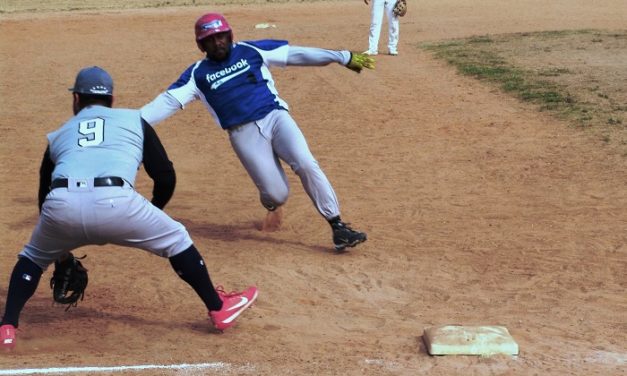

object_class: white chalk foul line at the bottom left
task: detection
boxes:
[0,362,240,375]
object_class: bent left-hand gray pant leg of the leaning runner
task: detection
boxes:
[229,117,289,210]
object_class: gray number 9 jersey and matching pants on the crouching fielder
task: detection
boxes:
[20,106,192,270]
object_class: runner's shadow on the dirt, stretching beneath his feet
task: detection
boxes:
[177,218,340,254]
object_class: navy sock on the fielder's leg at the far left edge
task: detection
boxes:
[0,256,43,328]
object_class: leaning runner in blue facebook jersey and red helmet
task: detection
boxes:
[141,13,374,251]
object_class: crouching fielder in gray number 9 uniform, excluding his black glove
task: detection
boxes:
[0,67,257,349]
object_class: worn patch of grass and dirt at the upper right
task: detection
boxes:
[420,29,627,155]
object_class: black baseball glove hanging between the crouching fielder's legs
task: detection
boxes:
[50,253,88,311]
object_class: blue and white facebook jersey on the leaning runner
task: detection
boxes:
[167,40,288,129]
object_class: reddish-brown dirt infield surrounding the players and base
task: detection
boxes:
[0,0,627,376]
